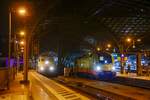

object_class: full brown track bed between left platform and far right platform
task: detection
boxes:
[55,77,150,100]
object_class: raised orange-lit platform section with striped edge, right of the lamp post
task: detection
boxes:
[29,71,90,100]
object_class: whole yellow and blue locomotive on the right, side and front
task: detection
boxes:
[76,52,116,80]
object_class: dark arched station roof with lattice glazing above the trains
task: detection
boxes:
[30,0,150,50]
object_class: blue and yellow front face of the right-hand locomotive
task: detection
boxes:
[94,53,116,80]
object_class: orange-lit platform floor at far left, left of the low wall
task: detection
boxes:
[0,73,31,100]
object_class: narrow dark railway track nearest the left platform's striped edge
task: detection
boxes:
[54,78,134,100]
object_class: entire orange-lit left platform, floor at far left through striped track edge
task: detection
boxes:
[0,71,90,100]
